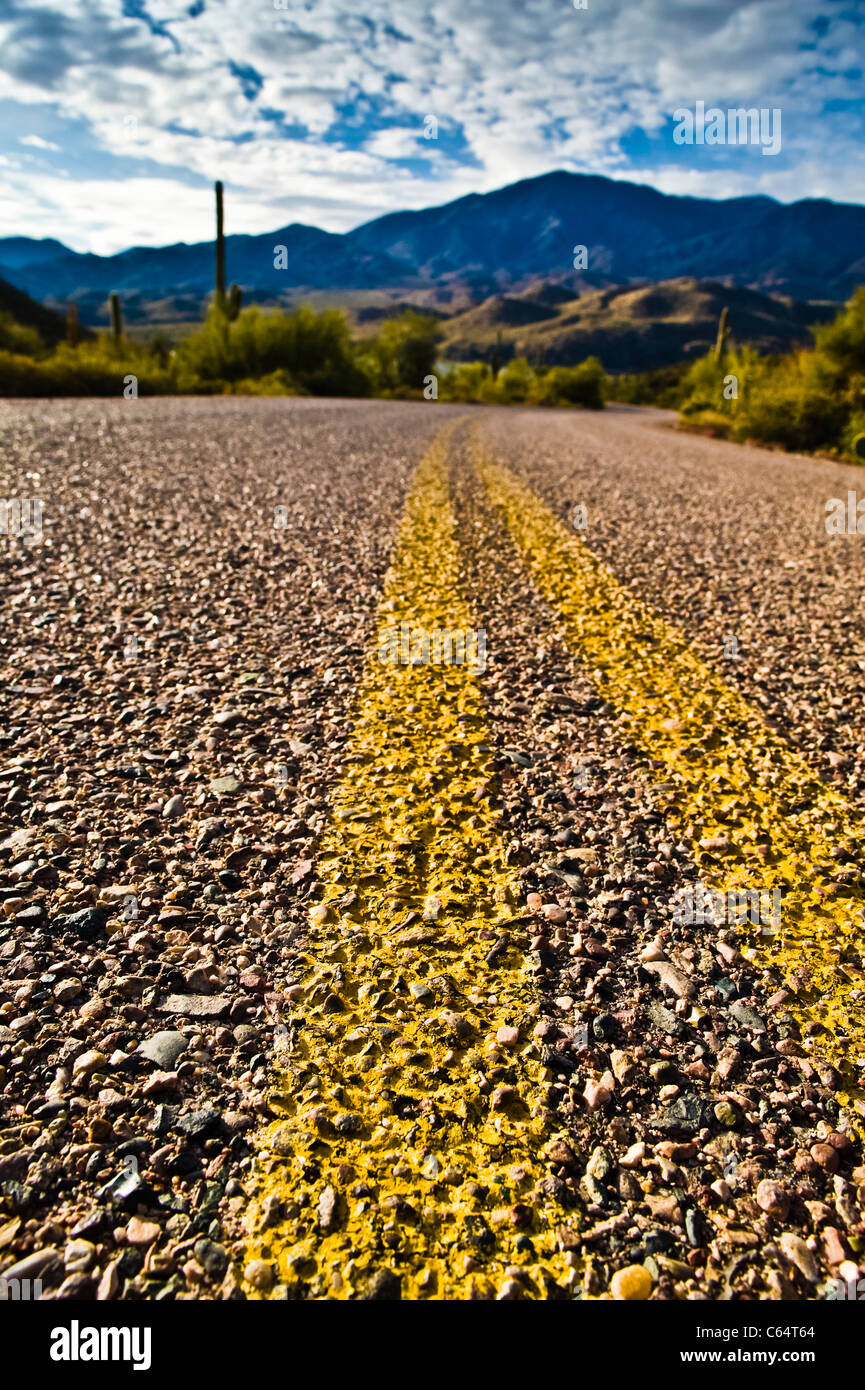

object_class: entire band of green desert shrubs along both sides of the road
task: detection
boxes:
[0,273,865,461]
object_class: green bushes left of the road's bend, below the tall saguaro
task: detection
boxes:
[0,306,605,410]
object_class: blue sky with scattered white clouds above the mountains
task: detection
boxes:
[0,0,865,254]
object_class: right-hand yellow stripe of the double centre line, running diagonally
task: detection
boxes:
[474,446,865,1113]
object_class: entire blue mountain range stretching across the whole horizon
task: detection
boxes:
[0,171,865,322]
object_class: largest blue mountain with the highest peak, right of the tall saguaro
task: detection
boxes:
[348,172,865,300]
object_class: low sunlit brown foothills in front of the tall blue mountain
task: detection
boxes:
[439,277,836,371]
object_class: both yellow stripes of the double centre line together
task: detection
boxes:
[245,417,865,1300]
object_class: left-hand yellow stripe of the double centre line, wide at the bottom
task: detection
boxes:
[245,432,573,1298]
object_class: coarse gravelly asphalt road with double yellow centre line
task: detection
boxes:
[0,399,865,1300]
